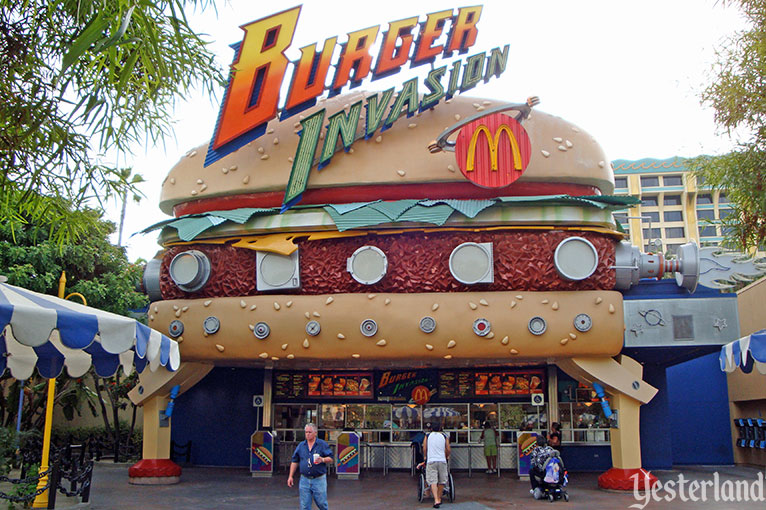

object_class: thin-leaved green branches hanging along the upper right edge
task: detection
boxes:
[689,0,766,250]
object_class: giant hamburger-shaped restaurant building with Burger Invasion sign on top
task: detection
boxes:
[131,7,728,489]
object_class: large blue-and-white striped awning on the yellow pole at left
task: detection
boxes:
[0,283,181,380]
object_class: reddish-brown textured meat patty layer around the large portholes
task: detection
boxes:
[160,230,616,299]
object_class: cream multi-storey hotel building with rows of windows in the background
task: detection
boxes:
[612,158,732,253]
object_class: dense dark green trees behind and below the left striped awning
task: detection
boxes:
[0,209,148,446]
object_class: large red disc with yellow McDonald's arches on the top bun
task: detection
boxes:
[455,113,532,188]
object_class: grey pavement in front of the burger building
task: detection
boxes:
[90,462,766,510]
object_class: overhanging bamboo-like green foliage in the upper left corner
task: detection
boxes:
[0,0,223,245]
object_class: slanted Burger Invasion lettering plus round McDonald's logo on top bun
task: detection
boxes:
[205,6,512,210]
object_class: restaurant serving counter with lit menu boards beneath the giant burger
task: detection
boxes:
[272,366,560,472]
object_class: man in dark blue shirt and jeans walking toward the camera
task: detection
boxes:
[287,423,332,510]
